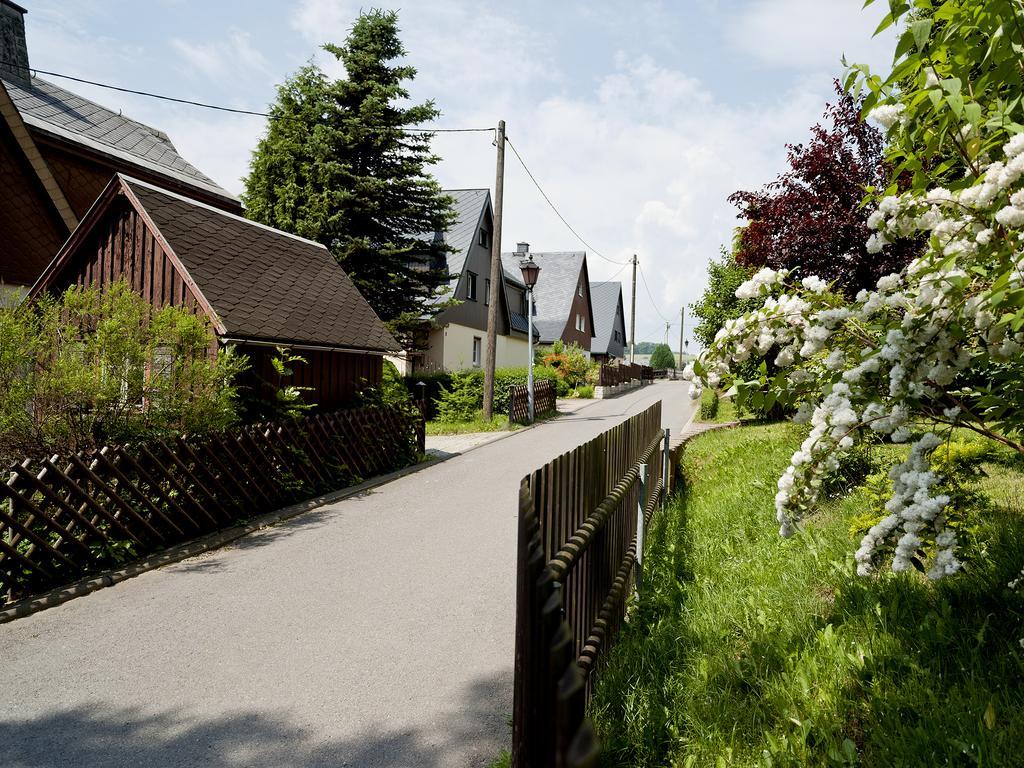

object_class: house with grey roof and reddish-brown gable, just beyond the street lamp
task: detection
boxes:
[502,243,594,353]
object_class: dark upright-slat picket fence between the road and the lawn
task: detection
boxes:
[512,402,675,768]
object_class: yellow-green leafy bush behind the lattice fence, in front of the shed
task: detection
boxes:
[0,282,248,464]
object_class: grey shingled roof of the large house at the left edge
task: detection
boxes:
[3,78,237,202]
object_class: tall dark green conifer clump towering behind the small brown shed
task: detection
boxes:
[243,10,454,344]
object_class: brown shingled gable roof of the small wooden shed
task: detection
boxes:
[32,174,401,352]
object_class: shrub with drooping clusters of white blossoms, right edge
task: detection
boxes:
[686,135,1024,579]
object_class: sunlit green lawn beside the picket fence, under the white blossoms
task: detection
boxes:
[591,424,1024,768]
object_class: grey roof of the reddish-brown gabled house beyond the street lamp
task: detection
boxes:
[502,251,594,339]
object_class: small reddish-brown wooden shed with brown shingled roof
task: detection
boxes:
[31,174,400,409]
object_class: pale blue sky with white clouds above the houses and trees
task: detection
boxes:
[19,0,895,348]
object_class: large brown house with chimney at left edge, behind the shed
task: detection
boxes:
[0,0,242,292]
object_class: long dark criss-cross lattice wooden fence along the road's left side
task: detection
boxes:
[0,408,423,605]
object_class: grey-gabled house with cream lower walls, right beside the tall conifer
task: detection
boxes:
[415,189,527,371]
